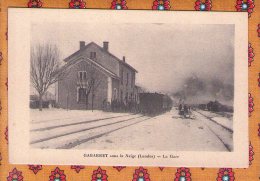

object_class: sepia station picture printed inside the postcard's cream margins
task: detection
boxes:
[30,22,235,151]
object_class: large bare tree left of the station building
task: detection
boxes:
[30,44,65,111]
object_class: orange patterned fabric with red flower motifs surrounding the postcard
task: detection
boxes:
[0,0,260,181]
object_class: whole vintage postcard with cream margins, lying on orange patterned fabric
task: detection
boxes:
[8,8,248,167]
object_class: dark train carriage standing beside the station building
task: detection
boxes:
[139,93,173,115]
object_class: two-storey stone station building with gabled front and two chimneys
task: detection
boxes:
[56,41,138,109]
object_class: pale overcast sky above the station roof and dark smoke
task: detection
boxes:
[31,21,234,92]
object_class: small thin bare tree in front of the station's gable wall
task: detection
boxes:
[78,63,102,111]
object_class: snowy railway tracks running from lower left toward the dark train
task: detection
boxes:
[30,115,151,149]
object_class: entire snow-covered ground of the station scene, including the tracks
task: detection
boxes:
[31,109,233,151]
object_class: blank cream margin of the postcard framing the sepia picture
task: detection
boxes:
[8,8,249,168]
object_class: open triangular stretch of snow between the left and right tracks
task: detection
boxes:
[76,110,232,151]
